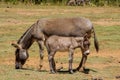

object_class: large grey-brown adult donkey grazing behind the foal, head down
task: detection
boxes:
[12,17,99,70]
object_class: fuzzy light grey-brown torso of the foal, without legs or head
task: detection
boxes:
[46,35,84,51]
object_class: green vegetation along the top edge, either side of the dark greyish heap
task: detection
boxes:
[0,0,120,6]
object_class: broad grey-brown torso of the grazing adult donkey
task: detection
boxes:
[37,17,92,37]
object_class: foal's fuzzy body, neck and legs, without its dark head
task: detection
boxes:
[45,35,84,74]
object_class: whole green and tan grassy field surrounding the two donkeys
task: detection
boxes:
[0,5,120,80]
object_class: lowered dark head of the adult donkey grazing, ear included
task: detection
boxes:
[11,43,28,69]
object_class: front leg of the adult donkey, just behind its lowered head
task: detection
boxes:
[37,41,44,70]
